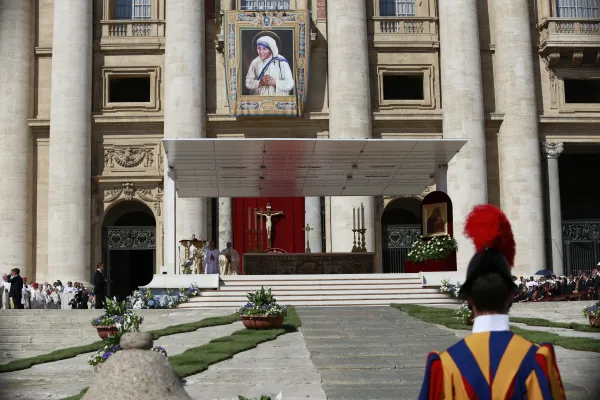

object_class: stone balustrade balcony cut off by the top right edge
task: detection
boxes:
[539,18,600,54]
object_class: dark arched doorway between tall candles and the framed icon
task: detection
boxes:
[381,197,421,273]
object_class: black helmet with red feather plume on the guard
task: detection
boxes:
[459,204,515,297]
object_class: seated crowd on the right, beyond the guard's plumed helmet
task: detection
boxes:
[513,268,600,302]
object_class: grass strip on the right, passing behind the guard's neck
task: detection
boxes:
[392,304,600,353]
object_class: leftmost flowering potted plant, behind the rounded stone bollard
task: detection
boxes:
[92,298,144,339]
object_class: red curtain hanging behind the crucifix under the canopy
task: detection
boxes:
[232,197,306,268]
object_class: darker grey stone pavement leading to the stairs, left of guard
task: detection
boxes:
[297,307,457,400]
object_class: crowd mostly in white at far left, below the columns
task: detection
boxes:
[0,274,94,310]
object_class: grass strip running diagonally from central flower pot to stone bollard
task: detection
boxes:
[63,306,302,400]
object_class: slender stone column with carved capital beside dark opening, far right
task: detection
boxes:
[542,143,564,276]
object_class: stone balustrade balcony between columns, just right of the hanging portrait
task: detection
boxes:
[373,17,440,48]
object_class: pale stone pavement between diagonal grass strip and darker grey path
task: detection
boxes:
[185,332,327,400]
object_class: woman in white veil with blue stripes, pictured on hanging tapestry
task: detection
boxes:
[246,36,294,96]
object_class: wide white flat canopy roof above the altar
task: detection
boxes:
[163,139,467,197]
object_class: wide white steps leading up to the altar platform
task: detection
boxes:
[179,274,456,309]
